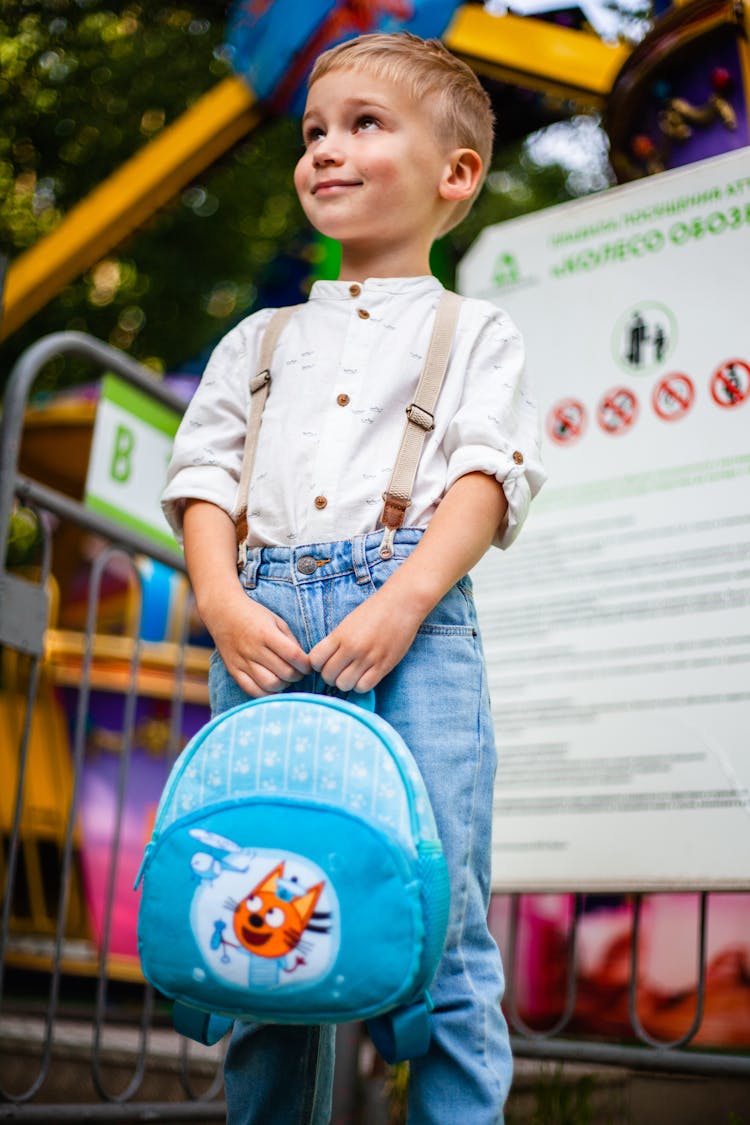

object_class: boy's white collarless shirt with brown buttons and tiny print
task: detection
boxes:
[162,277,545,547]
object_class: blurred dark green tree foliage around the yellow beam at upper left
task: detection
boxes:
[0,0,305,389]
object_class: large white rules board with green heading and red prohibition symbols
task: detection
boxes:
[459,149,750,891]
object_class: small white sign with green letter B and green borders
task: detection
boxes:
[85,375,180,551]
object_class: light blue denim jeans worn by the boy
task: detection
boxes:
[209,529,513,1125]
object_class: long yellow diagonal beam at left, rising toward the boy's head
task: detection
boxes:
[0,78,261,339]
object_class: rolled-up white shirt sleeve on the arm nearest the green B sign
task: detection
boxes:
[161,312,269,543]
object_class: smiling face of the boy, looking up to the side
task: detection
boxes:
[295,71,451,272]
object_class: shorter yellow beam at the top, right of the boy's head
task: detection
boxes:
[443,5,630,106]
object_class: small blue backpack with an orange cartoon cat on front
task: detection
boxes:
[136,693,449,1062]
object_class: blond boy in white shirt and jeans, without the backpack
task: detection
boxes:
[164,34,544,1125]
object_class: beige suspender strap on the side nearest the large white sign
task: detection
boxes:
[380,289,461,558]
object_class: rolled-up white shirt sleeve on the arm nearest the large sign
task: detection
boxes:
[444,303,546,549]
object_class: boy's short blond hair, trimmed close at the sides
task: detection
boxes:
[307,32,494,234]
